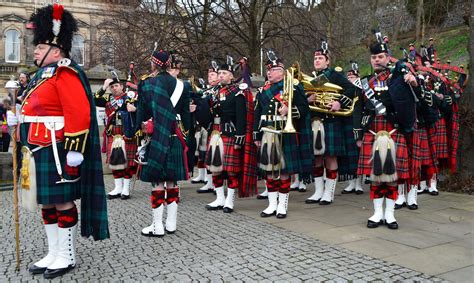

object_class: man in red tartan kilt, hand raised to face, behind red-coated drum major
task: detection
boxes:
[94,77,137,200]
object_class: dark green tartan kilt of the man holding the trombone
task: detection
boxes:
[258,134,301,174]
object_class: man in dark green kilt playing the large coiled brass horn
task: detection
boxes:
[306,41,356,205]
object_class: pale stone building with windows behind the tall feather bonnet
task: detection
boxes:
[0,0,131,97]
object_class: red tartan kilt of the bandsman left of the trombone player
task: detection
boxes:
[205,134,243,174]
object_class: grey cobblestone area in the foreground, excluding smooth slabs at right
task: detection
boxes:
[0,176,441,282]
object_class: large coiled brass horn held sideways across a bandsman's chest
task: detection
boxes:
[293,63,359,116]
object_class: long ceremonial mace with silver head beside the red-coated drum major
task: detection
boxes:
[5,76,20,271]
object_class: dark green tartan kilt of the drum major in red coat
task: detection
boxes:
[29,142,81,204]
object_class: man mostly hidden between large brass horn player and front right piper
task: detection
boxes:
[338,62,364,195]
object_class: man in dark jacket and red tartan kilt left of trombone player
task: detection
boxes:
[198,56,252,213]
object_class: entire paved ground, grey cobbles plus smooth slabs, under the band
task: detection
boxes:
[0,176,473,282]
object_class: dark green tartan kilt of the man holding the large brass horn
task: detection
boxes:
[323,117,347,156]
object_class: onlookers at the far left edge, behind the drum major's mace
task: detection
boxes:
[0,73,29,152]
